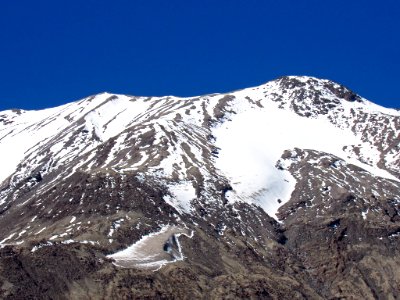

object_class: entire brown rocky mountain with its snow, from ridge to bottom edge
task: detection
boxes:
[0,77,400,299]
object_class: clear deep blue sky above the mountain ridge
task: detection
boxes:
[0,0,400,110]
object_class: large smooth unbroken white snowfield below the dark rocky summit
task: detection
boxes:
[213,90,399,217]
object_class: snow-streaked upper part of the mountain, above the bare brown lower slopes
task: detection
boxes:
[0,77,400,217]
